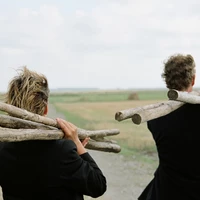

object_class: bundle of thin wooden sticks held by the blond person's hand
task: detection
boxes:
[0,102,121,153]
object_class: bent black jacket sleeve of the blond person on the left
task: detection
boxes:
[60,140,107,198]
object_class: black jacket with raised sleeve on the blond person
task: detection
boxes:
[0,139,106,200]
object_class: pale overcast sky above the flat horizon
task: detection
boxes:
[0,0,200,91]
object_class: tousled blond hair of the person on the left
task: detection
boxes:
[5,66,49,115]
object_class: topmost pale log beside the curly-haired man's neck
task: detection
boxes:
[167,89,200,104]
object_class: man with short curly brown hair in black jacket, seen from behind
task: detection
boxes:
[138,54,200,200]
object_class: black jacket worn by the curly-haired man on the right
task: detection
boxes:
[138,104,200,200]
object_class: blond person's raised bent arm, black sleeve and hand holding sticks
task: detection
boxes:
[57,119,107,197]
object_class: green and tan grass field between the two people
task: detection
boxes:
[50,90,167,159]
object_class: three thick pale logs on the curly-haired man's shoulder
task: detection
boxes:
[115,89,200,125]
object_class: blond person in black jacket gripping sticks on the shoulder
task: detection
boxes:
[0,67,107,200]
